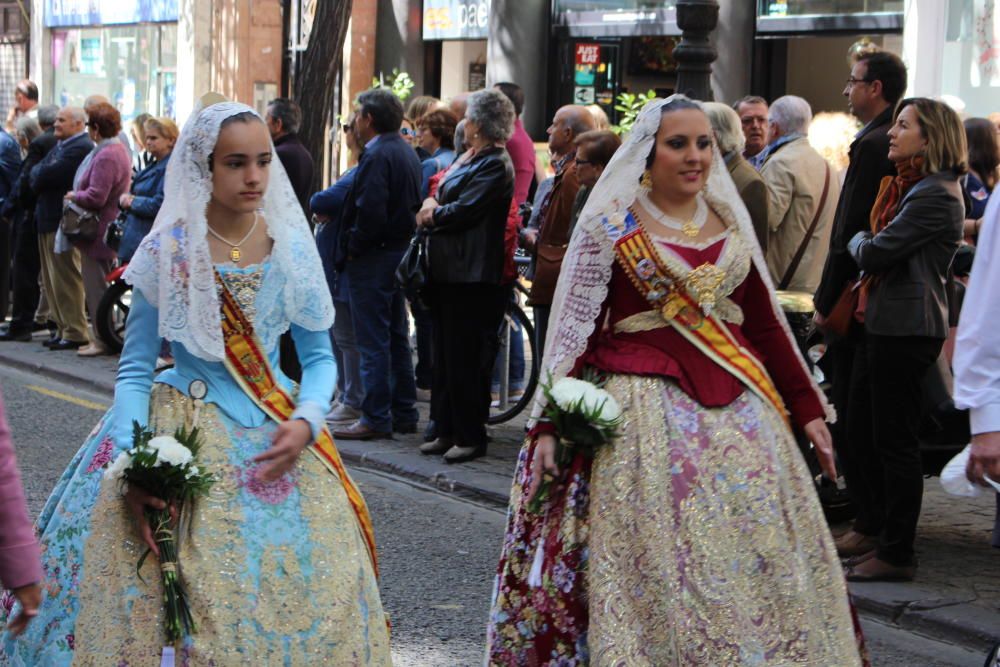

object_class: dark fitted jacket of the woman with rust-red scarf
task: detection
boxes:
[847,171,965,339]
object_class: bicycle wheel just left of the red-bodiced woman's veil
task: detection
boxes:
[486,303,541,424]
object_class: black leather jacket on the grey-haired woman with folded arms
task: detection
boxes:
[427,147,514,285]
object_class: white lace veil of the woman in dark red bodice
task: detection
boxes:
[529,95,836,426]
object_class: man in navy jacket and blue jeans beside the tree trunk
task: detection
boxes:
[334,88,421,440]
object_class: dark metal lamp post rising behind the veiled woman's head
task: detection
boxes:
[674,0,719,102]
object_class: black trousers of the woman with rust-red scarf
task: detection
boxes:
[847,334,944,566]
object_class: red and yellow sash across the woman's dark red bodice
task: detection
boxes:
[615,227,788,422]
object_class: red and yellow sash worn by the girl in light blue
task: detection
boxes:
[216,274,378,577]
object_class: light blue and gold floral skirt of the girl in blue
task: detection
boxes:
[0,385,391,667]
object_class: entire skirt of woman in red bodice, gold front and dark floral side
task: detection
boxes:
[487,375,862,667]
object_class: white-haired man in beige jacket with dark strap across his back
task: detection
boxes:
[760,95,840,294]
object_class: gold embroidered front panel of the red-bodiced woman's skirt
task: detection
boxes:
[587,375,860,667]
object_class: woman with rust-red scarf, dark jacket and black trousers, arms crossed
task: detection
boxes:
[846,98,968,581]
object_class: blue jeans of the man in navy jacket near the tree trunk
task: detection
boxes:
[345,250,419,431]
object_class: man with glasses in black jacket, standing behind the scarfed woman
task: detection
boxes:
[814,51,906,557]
